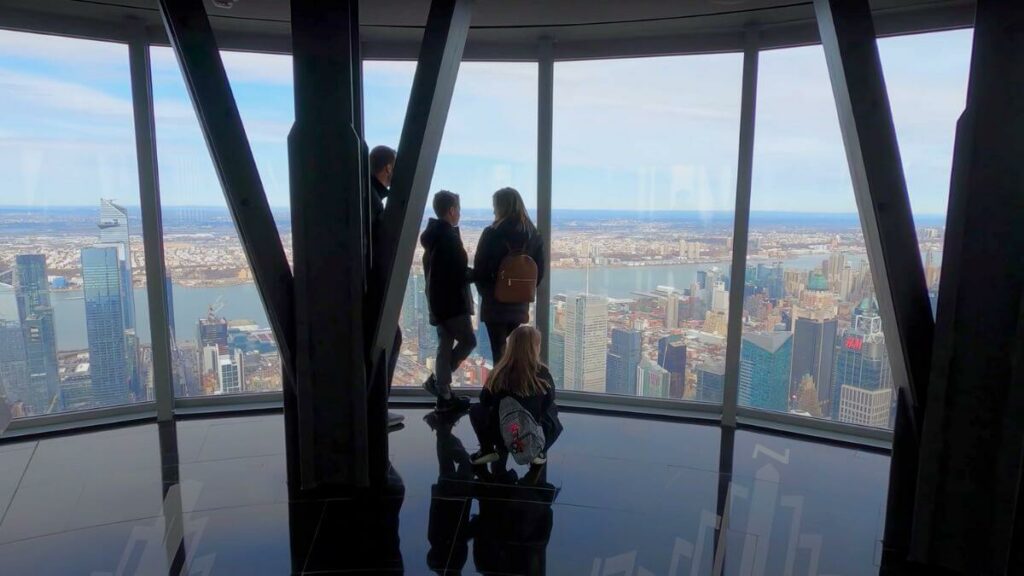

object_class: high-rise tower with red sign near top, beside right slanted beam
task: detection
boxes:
[830,298,893,426]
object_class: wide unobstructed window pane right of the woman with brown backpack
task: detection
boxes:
[548,53,742,403]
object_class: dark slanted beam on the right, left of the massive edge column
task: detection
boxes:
[814,0,934,561]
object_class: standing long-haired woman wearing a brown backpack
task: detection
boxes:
[473,188,548,366]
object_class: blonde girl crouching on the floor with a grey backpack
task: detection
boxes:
[469,326,562,476]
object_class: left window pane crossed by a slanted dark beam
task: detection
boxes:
[151,47,294,397]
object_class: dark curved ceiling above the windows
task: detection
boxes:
[0,0,974,59]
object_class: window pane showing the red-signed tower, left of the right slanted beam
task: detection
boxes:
[738,45,895,427]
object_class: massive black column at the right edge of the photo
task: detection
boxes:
[912,0,1024,574]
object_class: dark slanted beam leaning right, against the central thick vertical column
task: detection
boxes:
[368,0,470,482]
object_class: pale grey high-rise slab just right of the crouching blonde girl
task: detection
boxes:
[565,294,608,393]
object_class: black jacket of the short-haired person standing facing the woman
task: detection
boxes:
[420,218,473,326]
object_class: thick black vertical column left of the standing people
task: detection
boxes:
[288,0,370,488]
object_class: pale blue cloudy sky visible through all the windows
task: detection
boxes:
[0,31,972,213]
